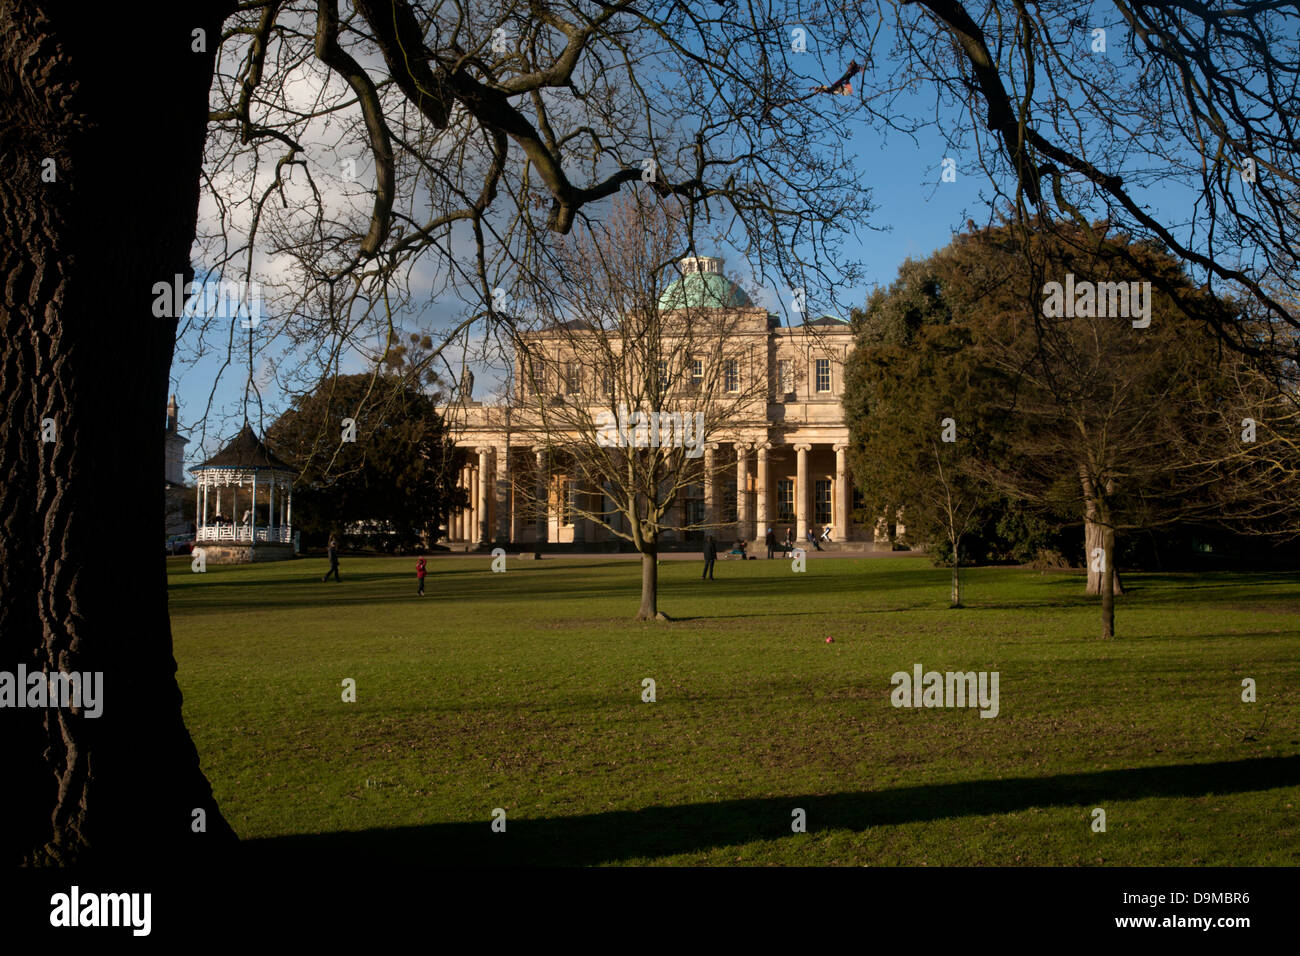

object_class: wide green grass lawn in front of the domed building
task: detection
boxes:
[169,555,1300,866]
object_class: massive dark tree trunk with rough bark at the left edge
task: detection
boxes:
[0,0,234,864]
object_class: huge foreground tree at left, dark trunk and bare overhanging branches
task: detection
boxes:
[0,0,870,862]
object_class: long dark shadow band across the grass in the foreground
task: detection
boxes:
[241,757,1300,866]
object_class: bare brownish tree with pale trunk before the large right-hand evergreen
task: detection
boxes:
[953,225,1274,637]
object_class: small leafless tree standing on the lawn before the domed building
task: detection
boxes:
[512,199,770,620]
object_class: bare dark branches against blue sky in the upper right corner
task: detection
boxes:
[810,0,1300,362]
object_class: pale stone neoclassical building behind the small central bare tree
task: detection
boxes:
[442,256,875,550]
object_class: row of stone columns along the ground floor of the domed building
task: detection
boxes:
[445,436,857,549]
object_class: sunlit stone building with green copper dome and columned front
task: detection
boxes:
[445,255,878,550]
